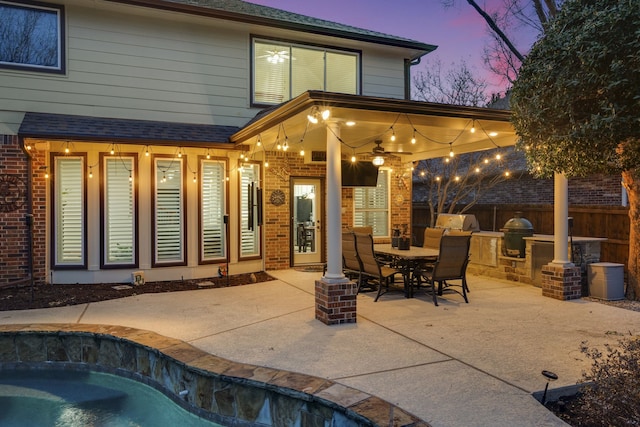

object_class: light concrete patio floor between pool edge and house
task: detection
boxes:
[0,270,640,427]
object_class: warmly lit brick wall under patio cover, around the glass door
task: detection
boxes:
[264,151,411,270]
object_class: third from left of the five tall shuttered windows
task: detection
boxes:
[153,156,187,267]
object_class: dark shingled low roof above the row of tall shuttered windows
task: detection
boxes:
[19,112,240,148]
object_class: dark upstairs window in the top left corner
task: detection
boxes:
[0,0,65,73]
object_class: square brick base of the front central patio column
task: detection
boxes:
[316,279,358,325]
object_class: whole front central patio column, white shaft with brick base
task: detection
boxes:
[315,120,358,325]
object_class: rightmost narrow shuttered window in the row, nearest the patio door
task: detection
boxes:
[239,163,260,258]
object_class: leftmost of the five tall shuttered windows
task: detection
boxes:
[53,156,87,268]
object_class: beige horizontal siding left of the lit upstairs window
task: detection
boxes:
[0,5,255,125]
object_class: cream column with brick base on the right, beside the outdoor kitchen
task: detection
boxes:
[542,173,582,300]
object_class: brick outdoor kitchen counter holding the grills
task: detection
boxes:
[467,231,607,287]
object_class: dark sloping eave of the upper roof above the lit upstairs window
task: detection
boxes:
[106,0,437,55]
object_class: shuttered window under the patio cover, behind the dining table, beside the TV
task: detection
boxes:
[353,169,390,237]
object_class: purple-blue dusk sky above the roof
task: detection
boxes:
[248,0,536,97]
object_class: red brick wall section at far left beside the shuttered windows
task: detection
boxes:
[0,135,46,286]
